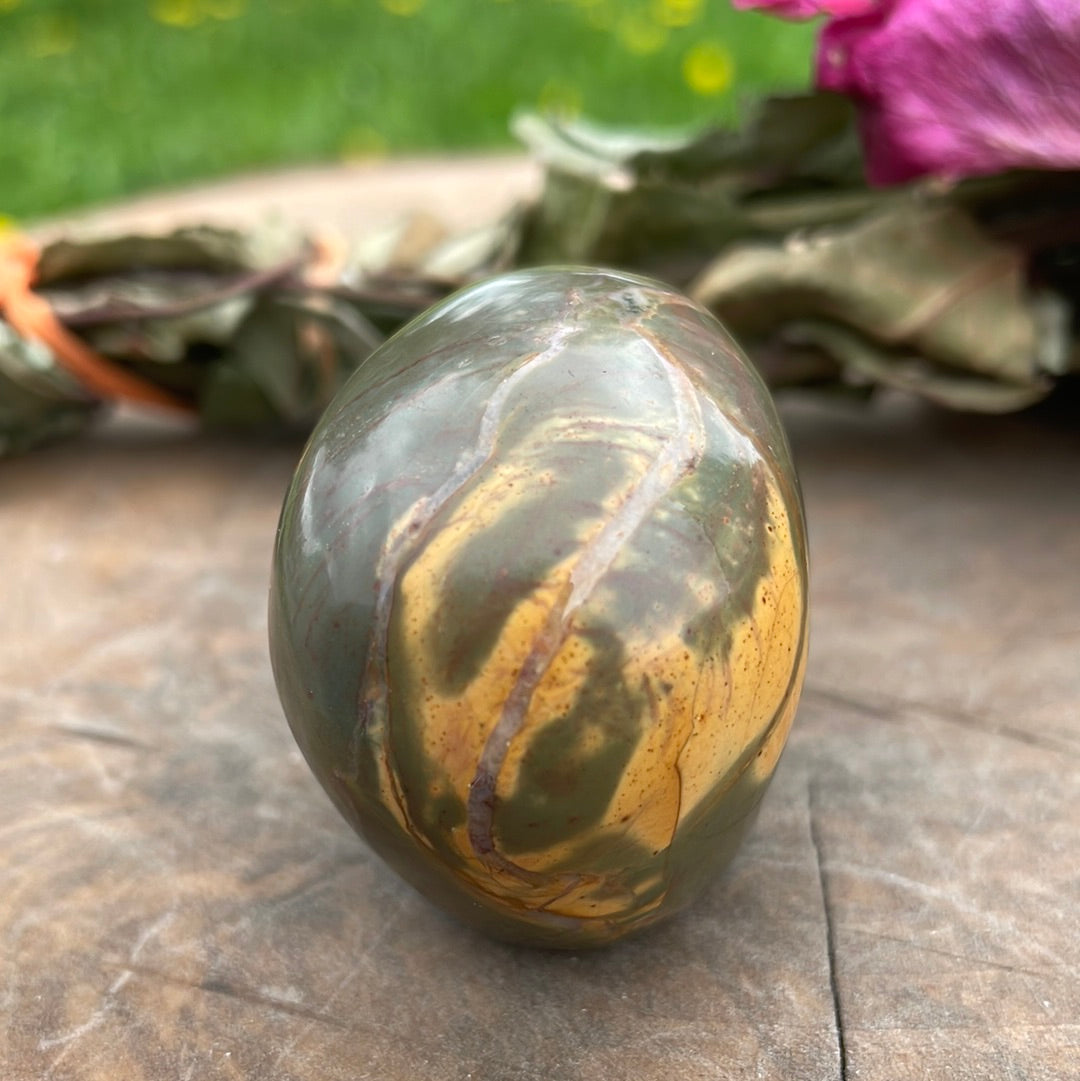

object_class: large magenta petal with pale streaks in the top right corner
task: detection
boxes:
[817,0,1080,184]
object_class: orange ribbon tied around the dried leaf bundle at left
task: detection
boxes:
[0,233,192,413]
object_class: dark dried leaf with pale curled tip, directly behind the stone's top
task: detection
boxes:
[516,94,869,284]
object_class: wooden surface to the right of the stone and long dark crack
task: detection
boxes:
[789,397,1080,1081]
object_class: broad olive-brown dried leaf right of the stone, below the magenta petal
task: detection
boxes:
[692,193,1067,408]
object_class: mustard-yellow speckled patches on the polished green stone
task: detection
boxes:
[371,425,805,919]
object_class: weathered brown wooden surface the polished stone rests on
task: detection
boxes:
[0,164,1080,1081]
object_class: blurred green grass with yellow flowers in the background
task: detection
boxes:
[0,0,813,221]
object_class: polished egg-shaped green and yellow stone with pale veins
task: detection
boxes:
[270,269,806,948]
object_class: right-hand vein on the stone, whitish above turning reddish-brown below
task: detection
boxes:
[467,338,705,881]
